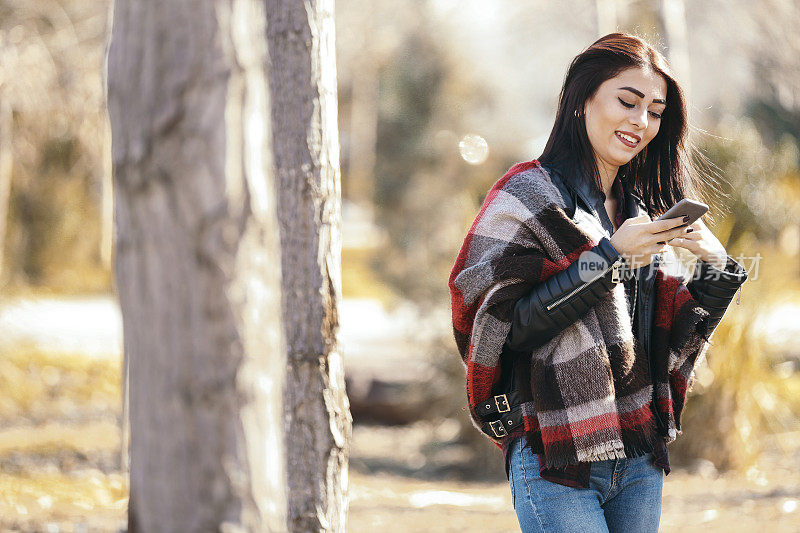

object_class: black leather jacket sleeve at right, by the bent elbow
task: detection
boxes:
[686,256,747,339]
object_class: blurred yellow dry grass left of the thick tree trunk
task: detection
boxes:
[0,346,128,531]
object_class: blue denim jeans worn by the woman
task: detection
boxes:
[508,437,664,533]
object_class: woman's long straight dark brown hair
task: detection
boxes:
[537,33,705,216]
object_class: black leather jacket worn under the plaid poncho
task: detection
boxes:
[506,165,747,382]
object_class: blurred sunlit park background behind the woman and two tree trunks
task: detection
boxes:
[0,0,800,532]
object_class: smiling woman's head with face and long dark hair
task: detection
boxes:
[538,33,704,216]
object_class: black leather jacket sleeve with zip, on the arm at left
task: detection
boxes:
[506,237,624,351]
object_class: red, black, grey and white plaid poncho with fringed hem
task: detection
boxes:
[449,160,708,468]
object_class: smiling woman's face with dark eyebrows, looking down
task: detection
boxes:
[584,67,667,175]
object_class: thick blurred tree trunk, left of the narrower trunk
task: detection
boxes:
[108,0,290,532]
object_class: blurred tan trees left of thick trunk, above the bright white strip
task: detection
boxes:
[0,0,112,292]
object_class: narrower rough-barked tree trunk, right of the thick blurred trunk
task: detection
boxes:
[266,0,352,531]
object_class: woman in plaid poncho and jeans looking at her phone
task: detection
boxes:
[450,33,747,532]
